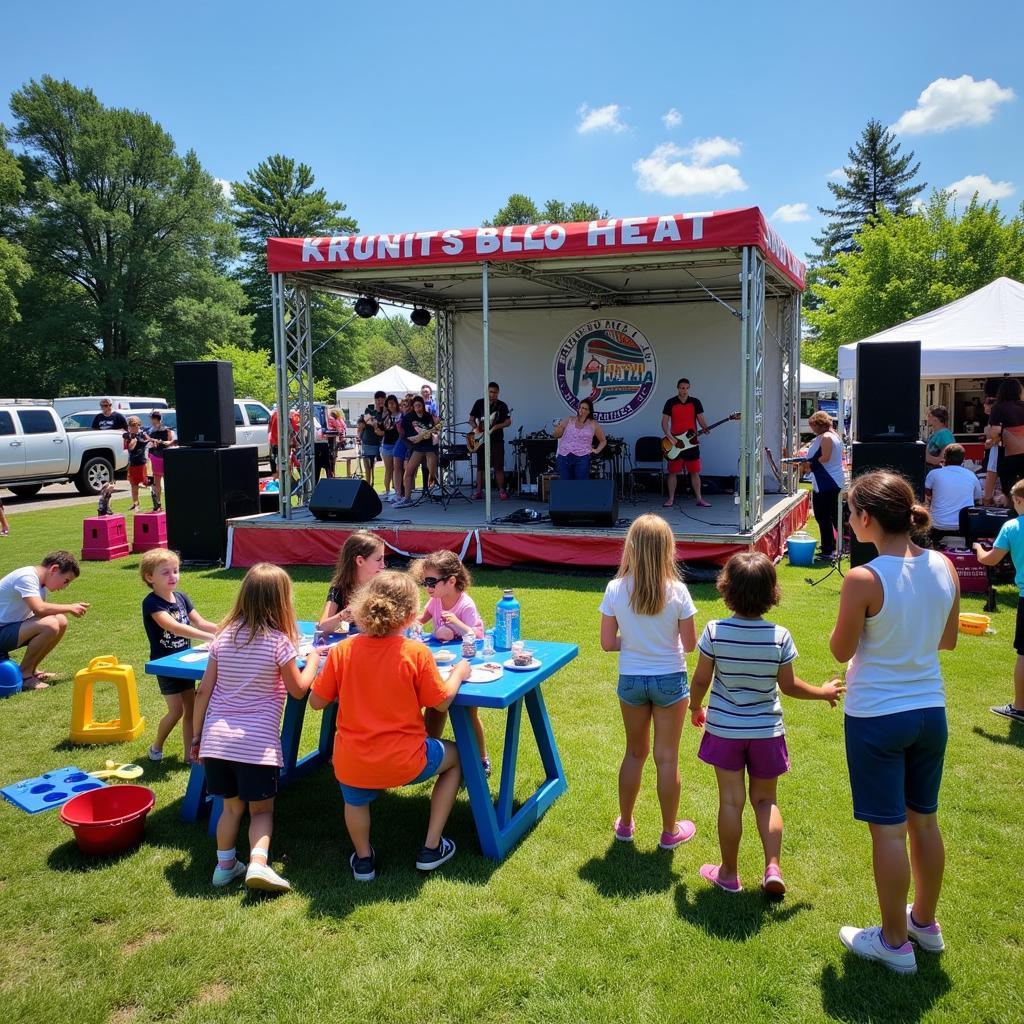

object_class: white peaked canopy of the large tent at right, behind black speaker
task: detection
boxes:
[839,278,1024,381]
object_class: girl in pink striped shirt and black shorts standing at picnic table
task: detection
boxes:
[191,562,326,892]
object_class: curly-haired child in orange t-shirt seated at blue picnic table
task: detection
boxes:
[309,571,470,882]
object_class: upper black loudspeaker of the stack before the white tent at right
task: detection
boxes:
[856,341,921,441]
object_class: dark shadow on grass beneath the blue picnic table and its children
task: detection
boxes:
[137,768,498,918]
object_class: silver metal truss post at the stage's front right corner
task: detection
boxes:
[739,246,765,532]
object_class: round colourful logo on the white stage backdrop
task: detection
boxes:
[555,319,657,423]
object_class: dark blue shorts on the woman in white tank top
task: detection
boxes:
[844,708,948,825]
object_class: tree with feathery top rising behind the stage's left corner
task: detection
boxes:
[231,154,368,387]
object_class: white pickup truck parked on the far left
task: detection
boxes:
[0,400,128,497]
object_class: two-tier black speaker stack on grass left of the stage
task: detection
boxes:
[164,360,260,562]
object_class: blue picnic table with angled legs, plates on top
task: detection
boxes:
[145,622,580,860]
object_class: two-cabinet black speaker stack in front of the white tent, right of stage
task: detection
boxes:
[850,341,926,565]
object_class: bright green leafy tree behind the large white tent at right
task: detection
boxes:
[802,190,1024,373]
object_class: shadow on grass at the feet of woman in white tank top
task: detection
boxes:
[821,954,950,1024]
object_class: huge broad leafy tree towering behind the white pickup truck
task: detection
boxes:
[0,76,251,395]
